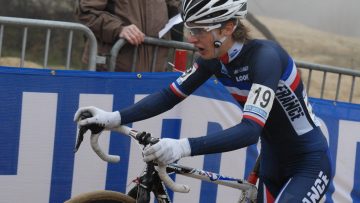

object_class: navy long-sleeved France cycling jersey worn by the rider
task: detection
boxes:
[121,40,330,201]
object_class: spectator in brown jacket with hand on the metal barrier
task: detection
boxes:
[75,0,180,72]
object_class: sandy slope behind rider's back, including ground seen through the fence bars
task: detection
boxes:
[245,16,360,103]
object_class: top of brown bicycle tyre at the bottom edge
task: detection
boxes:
[64,190,136,203]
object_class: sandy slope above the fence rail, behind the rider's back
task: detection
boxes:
[246,16,360,70]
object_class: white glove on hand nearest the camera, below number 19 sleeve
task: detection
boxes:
[144,138,191,165]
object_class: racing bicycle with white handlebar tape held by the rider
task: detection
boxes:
[65,114,259,203]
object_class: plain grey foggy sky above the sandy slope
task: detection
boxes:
[248,0,360,37]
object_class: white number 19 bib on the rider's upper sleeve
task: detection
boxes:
[244,83,275,120]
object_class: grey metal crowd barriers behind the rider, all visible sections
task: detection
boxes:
[0,16,360,103]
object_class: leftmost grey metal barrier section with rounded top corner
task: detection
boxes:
[0,16,98,70]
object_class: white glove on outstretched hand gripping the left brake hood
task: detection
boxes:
[74,106,121,130]
